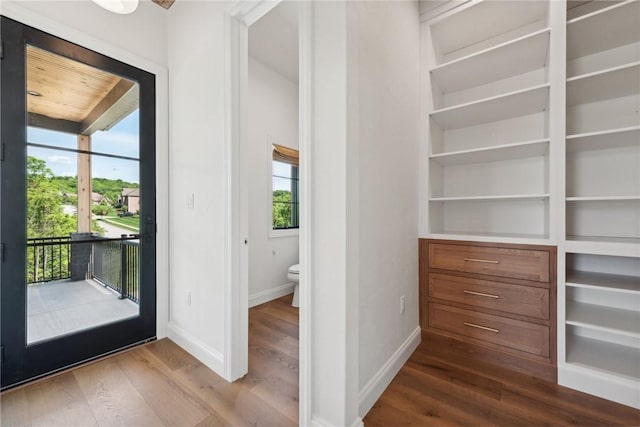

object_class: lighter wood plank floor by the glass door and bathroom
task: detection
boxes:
[0,295,298,427]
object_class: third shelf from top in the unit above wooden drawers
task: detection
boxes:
[429,139,549,166]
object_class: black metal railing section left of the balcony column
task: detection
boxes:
[27,236,71,284]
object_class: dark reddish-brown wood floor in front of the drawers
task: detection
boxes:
[364,334,640,427]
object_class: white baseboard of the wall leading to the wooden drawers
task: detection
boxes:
[359,326,421,418]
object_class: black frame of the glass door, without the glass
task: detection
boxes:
[0,16,156,389]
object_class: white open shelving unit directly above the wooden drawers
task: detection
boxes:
[423,0,552,243]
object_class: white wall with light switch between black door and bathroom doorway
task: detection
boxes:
[168,1,230,375]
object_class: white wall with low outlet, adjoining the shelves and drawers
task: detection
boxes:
[348,1,420,416]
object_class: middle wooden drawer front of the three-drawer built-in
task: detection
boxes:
[429,273,549,320]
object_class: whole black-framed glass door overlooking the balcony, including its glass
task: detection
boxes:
[0,17,156,388]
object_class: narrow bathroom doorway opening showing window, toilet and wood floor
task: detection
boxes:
[240,1,300,423]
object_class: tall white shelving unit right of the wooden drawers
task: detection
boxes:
[558,0,640,408]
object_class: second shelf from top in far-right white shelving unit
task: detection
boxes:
[567,61,640,106]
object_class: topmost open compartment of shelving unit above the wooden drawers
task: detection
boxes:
[431,1,548,63]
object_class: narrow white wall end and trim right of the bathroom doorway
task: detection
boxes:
[308,2,358,426]
